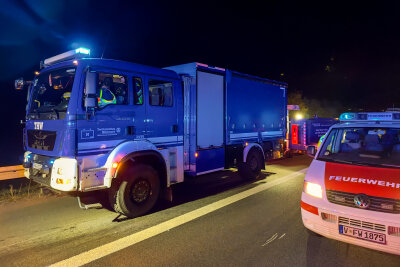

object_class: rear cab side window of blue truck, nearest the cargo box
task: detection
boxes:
[149,79,173,107]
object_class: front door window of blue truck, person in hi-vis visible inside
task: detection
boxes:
[96,72,128,108]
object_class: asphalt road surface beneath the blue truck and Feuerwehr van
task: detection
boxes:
[0,156,400,266]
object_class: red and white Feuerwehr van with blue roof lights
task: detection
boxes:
[301,112,400,255]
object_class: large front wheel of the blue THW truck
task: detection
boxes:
[110,164,160,218]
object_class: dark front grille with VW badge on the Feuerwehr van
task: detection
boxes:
[326,190,400,214]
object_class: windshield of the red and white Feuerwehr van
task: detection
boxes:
[318,127,400,167]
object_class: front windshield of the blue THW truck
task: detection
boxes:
[29,67,76,119]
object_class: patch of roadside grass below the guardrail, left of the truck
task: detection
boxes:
[0,178,58,205]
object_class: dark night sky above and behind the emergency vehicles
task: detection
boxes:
[0,0,400,166]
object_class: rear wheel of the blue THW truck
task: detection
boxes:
[238,148,264,180]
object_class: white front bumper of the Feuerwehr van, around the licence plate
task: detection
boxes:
[301,193,400,255]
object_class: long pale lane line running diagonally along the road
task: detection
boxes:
[50,168,308,266]
